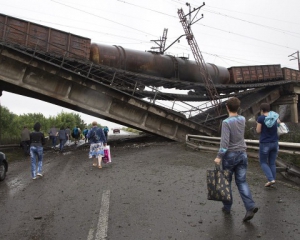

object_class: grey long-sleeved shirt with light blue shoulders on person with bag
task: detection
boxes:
[217,115,247,159]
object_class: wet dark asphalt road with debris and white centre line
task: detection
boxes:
[0,137,300,240]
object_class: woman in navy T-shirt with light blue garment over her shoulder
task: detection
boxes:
[256,103,280,187]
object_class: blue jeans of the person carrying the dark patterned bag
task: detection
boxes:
[222,151,255,211]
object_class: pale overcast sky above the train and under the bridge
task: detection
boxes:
[0,0,300,127]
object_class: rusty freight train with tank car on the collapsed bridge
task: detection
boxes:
[0,14,300,91]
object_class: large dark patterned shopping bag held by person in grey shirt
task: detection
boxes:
[206,165,231,201]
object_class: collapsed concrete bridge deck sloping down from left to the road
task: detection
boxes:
[0,45,217,141]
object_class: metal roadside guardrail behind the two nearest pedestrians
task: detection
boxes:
[186,134,300,178]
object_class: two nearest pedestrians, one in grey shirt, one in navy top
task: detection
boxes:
[214,97,280,222]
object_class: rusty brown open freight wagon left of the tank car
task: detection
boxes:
[0,14,91,59]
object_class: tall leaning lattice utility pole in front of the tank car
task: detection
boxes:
[177,3,221,116]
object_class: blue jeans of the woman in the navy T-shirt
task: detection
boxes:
[259,142,278,182]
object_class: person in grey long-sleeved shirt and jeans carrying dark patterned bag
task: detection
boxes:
[214,97,258,222]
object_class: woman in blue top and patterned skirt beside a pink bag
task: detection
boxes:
[87,121,107,168]
